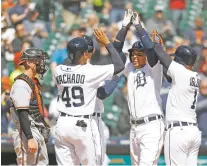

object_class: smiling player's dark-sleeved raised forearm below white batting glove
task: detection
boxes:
[114,26,128,53]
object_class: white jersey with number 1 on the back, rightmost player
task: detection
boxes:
[166,61,200,123]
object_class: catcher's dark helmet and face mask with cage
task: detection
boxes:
[19,48,49,79]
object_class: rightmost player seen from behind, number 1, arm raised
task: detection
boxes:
[137,11,201,165]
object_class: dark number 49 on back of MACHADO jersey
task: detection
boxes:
[62,86,85,107]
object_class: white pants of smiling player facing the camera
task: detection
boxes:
[130,119,164,166]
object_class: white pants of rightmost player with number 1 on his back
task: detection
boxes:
[164,126,201,166]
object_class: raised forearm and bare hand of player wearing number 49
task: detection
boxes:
[94,29,124,75]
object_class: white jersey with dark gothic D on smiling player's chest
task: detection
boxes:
[125,62,163,119]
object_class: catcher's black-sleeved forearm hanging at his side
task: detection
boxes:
[17,109,33,139]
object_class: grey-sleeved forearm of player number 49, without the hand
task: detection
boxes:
[106,43,124,75]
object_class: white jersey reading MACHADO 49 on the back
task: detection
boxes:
[55,64,114,115]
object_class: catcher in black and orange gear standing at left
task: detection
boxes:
[10,48,49,165]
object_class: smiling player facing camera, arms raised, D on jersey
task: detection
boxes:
[115,10,164,166]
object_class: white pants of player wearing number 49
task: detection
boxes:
[55,116,99,165]
